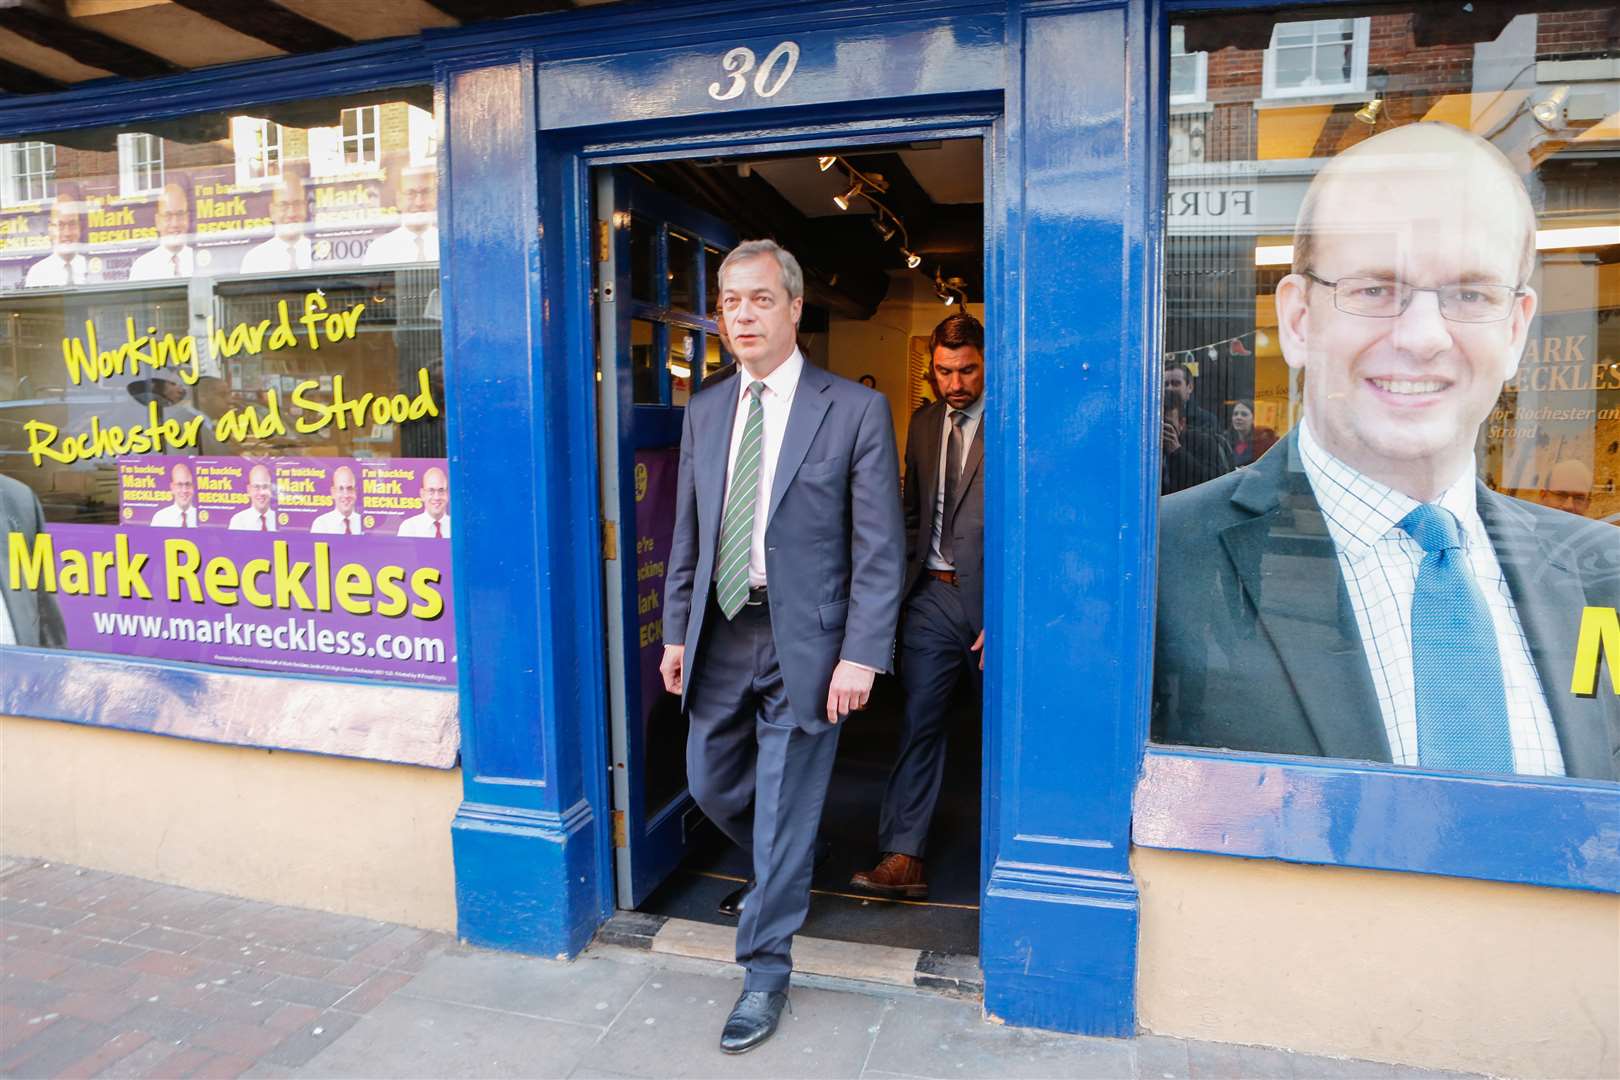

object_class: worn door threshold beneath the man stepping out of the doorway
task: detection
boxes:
[596,912,985,997]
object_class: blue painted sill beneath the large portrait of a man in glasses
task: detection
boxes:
[1132,746,1620,892]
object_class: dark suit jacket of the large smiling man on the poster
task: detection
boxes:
[1153,434,1620,780]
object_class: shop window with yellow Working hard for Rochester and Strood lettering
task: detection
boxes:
[0,87,455,685]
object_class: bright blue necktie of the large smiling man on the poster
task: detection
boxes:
[1400,504,1513,772]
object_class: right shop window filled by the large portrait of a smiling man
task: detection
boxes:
[1152,5,1620,780]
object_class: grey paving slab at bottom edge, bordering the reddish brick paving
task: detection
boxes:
[303,997,601,1078]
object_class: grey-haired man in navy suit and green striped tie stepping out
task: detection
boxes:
[661,240,904,1054]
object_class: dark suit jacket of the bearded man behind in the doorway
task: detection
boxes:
[901,402,985,630]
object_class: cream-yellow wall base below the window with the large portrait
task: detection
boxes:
[1132,848,1620,1077]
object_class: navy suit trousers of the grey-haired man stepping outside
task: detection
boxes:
[687,591,839,991]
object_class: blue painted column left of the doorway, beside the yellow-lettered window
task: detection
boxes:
[439,55,611,955]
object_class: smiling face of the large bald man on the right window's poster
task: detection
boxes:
[1277,154,1536,499]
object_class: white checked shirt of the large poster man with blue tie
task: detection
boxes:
[1299,421,1563,776]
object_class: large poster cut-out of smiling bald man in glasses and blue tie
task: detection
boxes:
[1153,123,1620,779]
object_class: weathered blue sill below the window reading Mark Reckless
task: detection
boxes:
[0,646,457,769]
